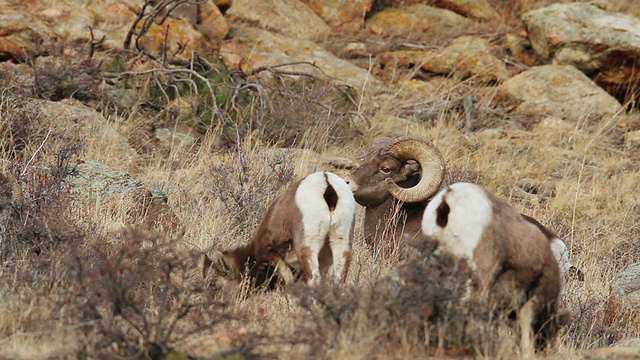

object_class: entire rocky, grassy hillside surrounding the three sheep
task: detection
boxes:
[0,0,640,359]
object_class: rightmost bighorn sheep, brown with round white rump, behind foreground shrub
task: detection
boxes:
[422,183,570,355]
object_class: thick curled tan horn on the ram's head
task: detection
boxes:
[386,137,445,203]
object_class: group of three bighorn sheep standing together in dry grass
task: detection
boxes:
[203,137,582,356]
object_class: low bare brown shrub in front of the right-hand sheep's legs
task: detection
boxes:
[293,249,499,357]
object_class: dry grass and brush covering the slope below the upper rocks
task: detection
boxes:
[0,0,640,359]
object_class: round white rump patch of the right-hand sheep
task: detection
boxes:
[422,183,493,259]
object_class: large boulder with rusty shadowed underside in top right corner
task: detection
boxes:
[523,2,640,99]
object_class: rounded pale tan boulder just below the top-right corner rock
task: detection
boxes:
[499,65,621,120]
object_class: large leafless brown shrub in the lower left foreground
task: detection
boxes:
[59,230,255,359]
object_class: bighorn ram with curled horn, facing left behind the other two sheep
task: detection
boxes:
[347,136,583,279]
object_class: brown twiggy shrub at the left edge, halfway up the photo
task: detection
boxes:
[0,88,83,261]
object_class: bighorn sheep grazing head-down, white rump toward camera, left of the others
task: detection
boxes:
[203,172,355,287]
